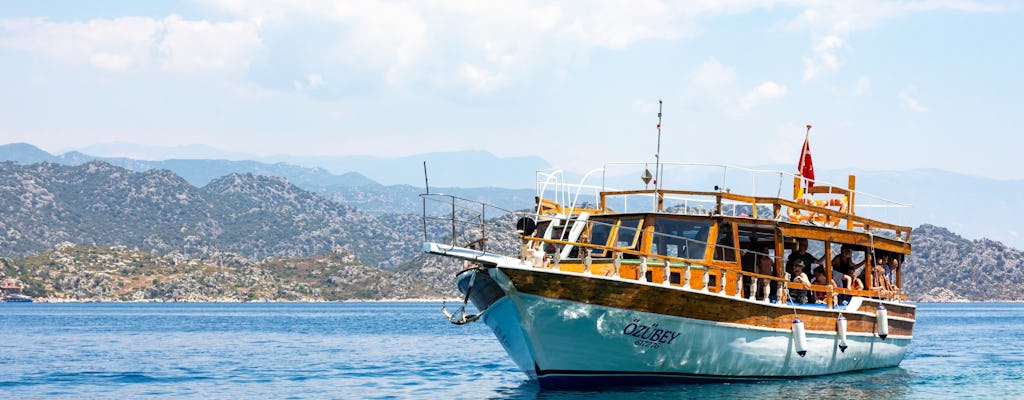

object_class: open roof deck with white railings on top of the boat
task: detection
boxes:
[537,163,911,244]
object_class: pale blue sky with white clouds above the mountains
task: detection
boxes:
[0,0,1024,180]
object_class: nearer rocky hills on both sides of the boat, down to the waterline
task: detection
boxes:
[0,155,1024,301]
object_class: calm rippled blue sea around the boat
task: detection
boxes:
[0,303,1024,399]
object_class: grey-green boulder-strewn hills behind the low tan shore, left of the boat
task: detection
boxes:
[0,162,436,267]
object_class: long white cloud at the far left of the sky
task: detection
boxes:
[0,14,261,71]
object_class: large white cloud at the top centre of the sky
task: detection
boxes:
[203,0,745,91]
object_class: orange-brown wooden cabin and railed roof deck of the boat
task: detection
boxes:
[425,163,910,305]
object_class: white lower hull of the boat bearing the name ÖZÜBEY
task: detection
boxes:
[471,268,910,388]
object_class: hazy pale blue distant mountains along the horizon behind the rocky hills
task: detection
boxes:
[0,143,1024,248]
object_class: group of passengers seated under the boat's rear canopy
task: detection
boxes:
[756,238,899,304]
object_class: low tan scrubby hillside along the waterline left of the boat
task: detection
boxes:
[0,243,439,302]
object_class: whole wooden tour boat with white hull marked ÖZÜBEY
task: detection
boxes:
[423,164,915,388]
